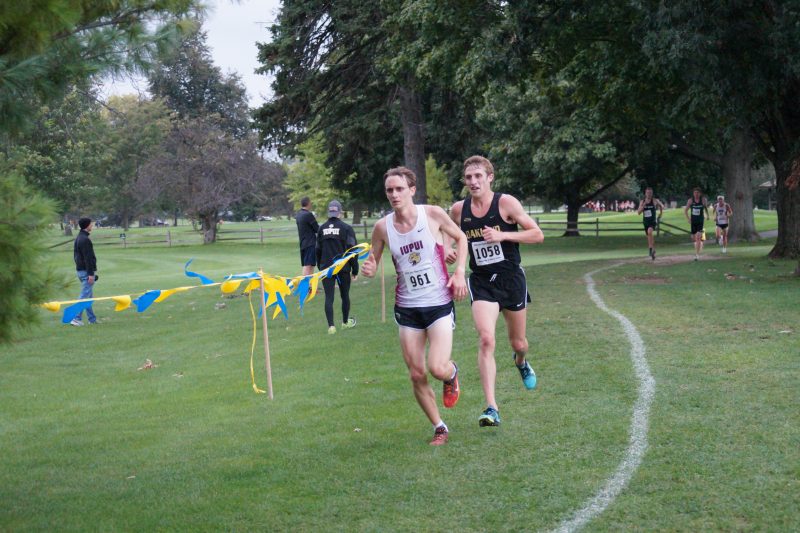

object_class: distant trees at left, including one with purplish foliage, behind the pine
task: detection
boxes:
[5,23,288,242]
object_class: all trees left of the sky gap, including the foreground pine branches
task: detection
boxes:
[0,0,288,342]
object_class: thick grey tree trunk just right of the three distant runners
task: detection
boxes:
[720,130,759,242]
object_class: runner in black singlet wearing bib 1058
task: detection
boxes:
[448,156,544,427]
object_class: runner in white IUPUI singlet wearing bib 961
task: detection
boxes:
[361,167,467,446]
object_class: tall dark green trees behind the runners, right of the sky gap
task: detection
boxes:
[255,0,800,257]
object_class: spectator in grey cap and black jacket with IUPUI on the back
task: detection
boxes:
[317,200,358,335]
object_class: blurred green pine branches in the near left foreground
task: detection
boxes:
[0,0,205,342]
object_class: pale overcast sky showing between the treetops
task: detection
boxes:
[104,0,280,107]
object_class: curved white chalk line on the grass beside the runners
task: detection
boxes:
[555,263,656,532]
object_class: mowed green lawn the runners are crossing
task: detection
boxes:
[0,227,800,531]
